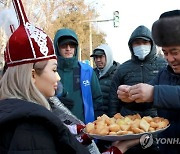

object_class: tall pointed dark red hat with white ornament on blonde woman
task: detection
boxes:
[5,0,56,67]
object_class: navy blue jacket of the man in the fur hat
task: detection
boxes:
[152,66,180,154]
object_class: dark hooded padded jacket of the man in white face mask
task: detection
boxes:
[109,26,167,116]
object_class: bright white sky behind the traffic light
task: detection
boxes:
[88,0,180,63]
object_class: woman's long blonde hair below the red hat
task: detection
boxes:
[0,61,50,109]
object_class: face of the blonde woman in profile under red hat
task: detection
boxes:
[32,59,60,98]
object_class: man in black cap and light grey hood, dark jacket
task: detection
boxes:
[91,44,120,114]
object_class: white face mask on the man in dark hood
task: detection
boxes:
[133,45,151,60]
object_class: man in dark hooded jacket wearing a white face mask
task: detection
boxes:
[109,25,167,153]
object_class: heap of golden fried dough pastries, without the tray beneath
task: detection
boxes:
[85,113,169,136]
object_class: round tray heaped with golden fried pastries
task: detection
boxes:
[84,113,170,141]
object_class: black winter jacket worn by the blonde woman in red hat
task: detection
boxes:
[0,99,89,154]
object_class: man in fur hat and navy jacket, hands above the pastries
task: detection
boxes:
[118,10,180,154]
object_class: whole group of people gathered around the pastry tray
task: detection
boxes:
[0,0,180,154]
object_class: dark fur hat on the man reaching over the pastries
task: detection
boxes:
[152,10,180,47]
